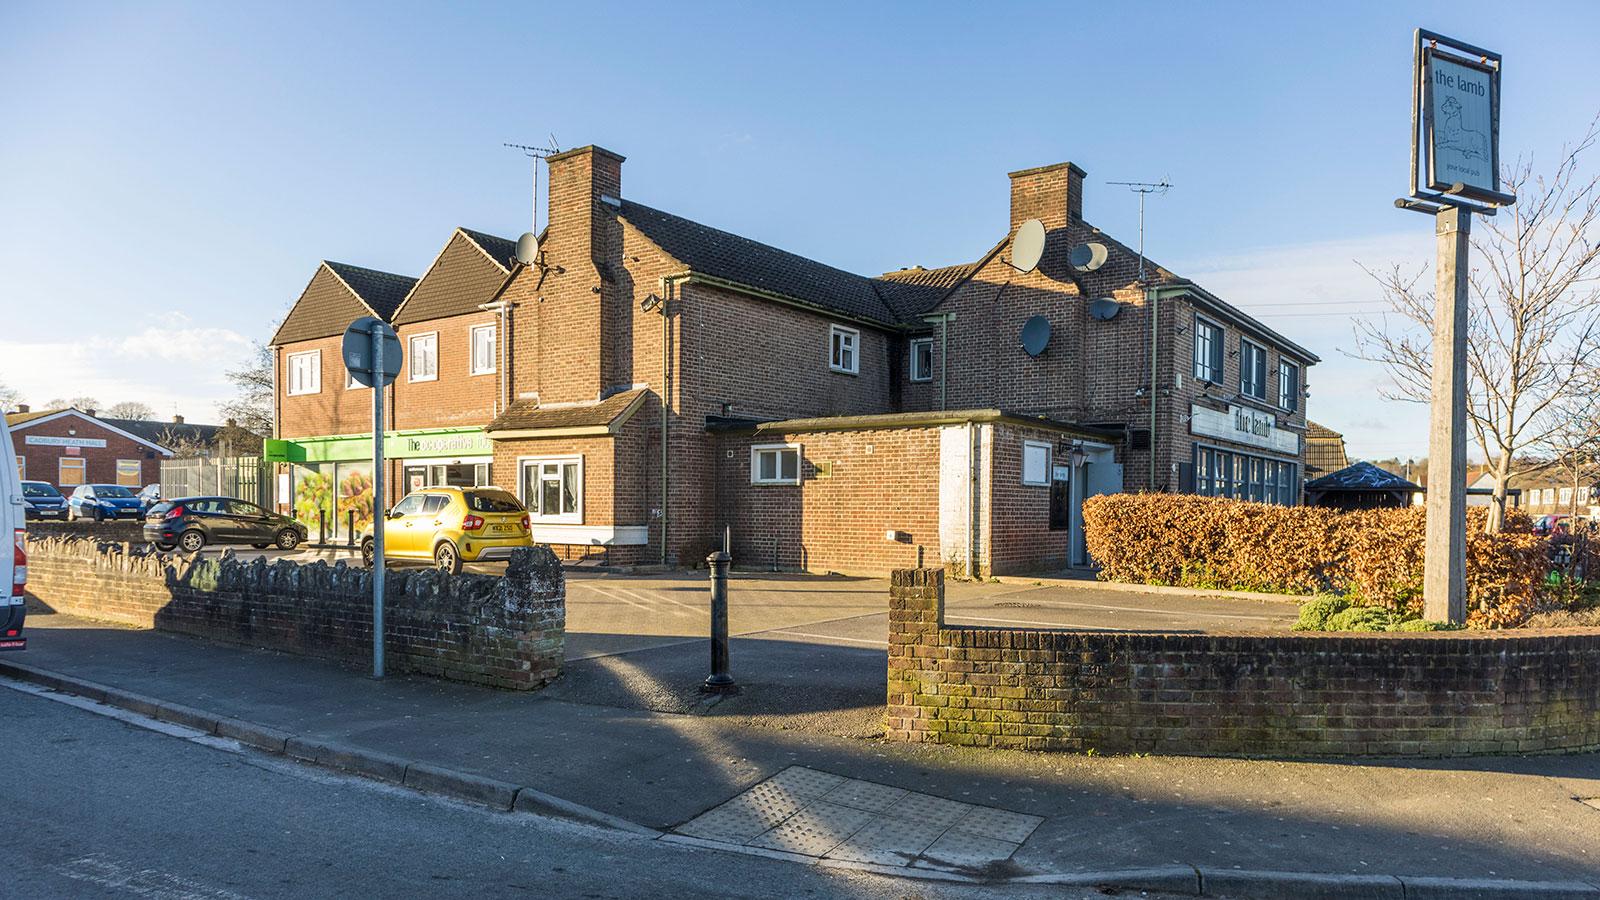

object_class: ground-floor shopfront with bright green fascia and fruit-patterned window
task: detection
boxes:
[264,428,494,540]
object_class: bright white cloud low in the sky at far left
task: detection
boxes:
[0,312,250,421]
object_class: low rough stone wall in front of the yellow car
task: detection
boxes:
[27,535,566,690]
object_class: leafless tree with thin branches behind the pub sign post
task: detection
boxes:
[1352,119,1600,530]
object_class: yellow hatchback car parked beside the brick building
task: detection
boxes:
[362,487,533,573]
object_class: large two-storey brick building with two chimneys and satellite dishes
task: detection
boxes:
[269,147,1317,573]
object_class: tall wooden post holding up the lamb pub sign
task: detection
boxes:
[1422,207,1472,625]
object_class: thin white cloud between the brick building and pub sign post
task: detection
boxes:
[1174,229,1434,458]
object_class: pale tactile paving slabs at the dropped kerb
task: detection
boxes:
[677,765,1043,868]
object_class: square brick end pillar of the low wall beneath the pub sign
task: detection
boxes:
[885,569,944,741]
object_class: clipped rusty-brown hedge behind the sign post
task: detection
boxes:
[1083,493,1550,628]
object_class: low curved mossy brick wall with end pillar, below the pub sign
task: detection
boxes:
[888,569,1600,756]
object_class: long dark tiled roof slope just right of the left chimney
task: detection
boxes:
[622,200,899,325]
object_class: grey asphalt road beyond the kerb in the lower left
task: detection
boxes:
[0,682,1126,900]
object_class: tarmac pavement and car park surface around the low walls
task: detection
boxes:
[12,573,1600,897]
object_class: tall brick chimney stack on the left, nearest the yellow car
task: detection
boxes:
[538,146,632,404]
